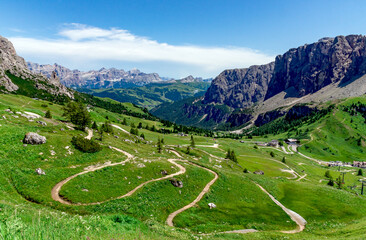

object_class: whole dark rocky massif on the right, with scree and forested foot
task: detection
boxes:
[152,35,366,128]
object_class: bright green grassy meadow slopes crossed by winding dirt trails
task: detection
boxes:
[0,95,366,239]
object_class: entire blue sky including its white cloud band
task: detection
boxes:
[0,0,366,78]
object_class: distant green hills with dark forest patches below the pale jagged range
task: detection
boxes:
[79,82,210,109]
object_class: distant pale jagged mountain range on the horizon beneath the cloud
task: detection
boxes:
[27,62,162,88]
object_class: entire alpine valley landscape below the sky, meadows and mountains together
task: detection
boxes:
[0,29,366,240]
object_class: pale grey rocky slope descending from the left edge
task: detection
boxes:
[0,36,73,98]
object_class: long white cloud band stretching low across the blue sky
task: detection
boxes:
[9,24,274,76]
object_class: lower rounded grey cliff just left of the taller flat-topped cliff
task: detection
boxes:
[203,63,274,108]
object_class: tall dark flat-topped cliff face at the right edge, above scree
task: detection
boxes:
[265,35,366,99]
